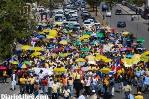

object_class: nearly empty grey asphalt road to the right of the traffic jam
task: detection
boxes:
[99,5,149,49]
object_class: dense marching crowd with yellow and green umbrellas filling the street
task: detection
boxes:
[1,16,149,99]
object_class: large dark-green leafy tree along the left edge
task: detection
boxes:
[0,0,34,60]
